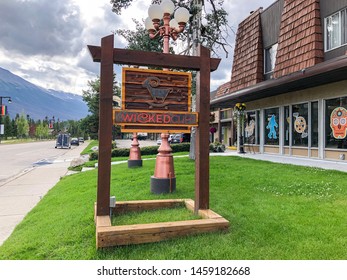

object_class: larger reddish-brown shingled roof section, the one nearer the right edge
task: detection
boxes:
[274,0,324,78]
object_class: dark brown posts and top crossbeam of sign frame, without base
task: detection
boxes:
[88,41,220,216]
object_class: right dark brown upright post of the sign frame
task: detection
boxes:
[195,46,211,213]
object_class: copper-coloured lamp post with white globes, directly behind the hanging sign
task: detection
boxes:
[145,0,190,194]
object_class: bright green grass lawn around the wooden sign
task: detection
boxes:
[0,157,347,260]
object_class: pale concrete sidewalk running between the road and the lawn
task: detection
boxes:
[0,145,85,245]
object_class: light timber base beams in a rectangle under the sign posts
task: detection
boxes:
[96,199,229,248]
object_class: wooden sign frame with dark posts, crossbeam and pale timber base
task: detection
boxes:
[88,35,229,248]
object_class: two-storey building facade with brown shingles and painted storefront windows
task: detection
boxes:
[211,0,347,161]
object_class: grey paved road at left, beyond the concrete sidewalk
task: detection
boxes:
[0,141,81,186]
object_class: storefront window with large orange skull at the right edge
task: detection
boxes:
[325,97,347,149]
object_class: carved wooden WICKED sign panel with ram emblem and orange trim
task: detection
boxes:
[113,68,198,132]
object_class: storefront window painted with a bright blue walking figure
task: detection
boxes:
[264,108,279,145]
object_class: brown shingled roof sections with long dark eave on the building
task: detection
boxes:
[211,0,347,108]
